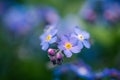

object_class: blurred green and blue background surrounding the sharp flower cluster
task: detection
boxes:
[0,0,120,80]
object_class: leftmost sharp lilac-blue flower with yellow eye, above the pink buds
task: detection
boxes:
[40,29,57,50]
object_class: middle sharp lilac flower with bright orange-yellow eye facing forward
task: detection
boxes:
[58,36,81,57]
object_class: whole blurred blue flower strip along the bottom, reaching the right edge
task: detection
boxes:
[54,60,120,80]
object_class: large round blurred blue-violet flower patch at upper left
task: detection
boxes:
[3,5,40,34]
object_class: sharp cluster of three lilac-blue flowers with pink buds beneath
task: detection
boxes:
[40,26,90,64]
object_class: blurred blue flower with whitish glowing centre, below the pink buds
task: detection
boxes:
[54,60,94,80]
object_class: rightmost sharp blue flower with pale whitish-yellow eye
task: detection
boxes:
[72,27,90,48]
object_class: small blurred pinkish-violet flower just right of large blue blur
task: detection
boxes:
[38,6,60,25]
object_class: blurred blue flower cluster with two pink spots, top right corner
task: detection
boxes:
[80,0,120,25]
